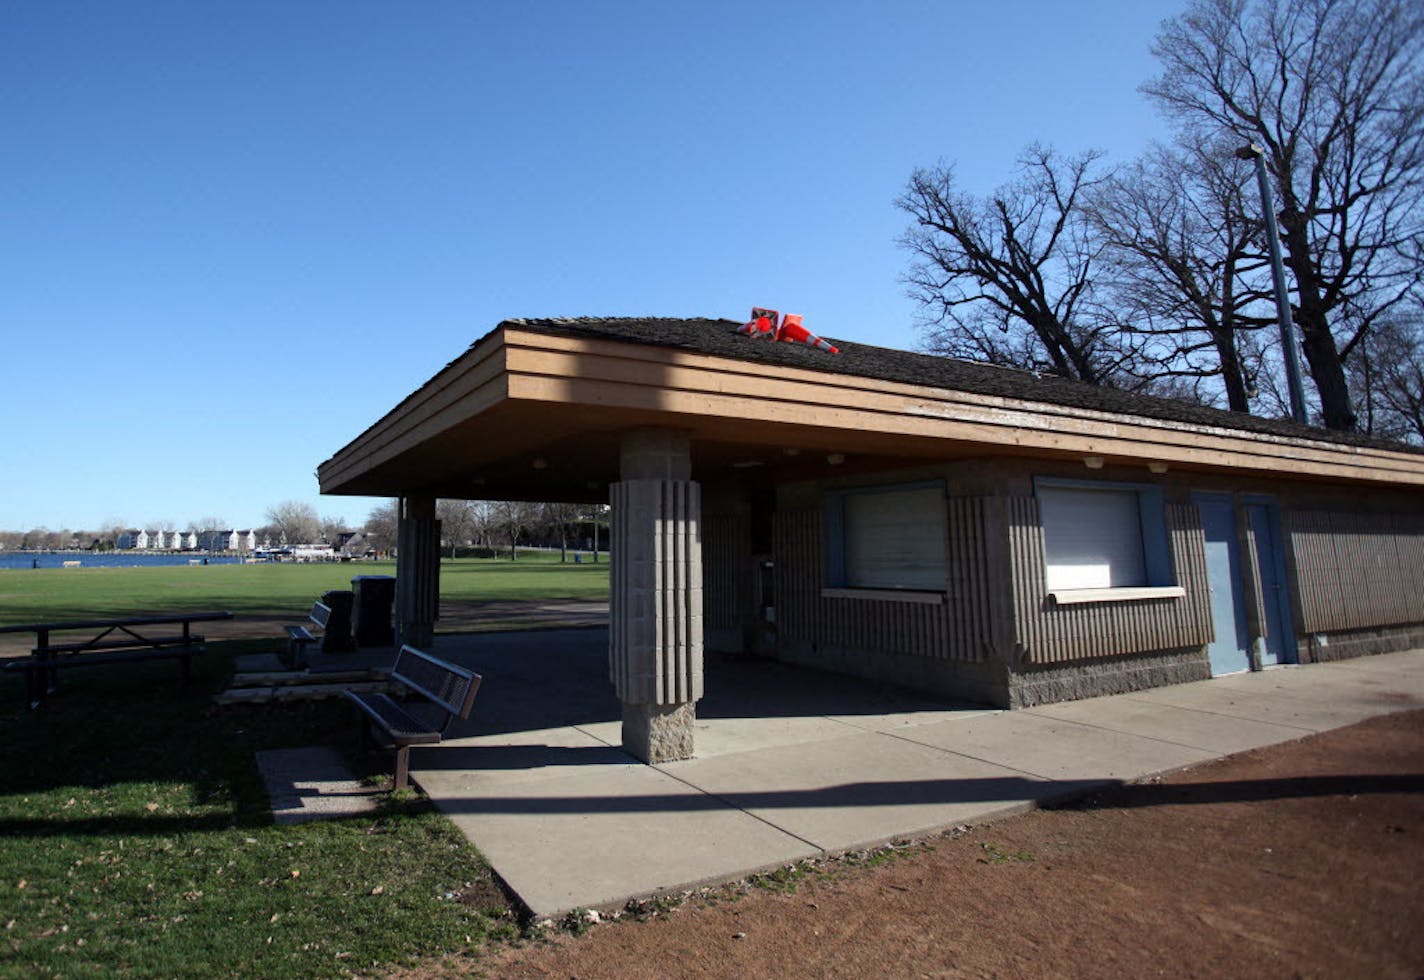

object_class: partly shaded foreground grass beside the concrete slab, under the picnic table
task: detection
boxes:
[0,638,517,977]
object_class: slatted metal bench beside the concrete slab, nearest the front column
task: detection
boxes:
[346,645,480,789]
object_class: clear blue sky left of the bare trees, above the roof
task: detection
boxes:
[0,0,1180,530]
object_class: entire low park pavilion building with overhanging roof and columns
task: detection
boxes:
[319,318,1424,761]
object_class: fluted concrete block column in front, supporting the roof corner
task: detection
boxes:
[608,429,702,762]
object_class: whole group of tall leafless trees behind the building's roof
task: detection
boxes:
[897,0,1424,440]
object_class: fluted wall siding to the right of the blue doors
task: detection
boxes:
[1282,511,1424,632]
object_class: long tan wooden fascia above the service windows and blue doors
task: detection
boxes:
[507,330,1424,484]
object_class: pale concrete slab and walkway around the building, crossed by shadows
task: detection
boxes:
[412,630,1424,916]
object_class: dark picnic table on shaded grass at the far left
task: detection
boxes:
[0,613,232,709]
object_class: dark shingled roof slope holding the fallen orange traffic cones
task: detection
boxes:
[500,316,1424,454]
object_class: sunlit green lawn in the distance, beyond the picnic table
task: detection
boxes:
[0,551,608,625]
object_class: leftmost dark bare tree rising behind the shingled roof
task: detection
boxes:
[896,145,1134,385]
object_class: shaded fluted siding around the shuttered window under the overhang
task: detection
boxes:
[773,499,993,661]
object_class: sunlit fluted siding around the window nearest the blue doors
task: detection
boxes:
[1008,497,1212,664]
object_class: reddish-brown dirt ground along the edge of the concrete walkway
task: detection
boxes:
[400,711,1424,980]
